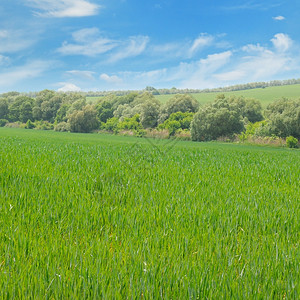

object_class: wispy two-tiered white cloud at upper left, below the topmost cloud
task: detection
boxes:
[57,28,117,56]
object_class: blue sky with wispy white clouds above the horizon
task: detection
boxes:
[0,0,300,93]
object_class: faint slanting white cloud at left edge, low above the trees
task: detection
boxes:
[0,60,53,89]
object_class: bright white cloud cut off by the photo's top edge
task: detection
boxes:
[26,0,100,18]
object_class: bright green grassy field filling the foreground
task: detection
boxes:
[0,128,300,299]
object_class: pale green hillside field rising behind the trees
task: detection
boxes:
[87,84,300,107]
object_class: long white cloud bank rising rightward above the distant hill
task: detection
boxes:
[101,34,300,89]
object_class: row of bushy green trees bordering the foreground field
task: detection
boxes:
[0,90,300,146]
